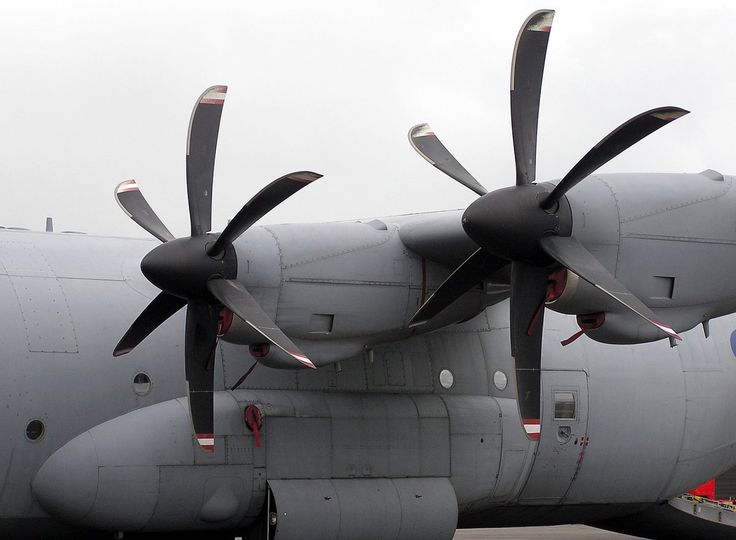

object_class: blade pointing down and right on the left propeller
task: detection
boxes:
[207,279,316,369]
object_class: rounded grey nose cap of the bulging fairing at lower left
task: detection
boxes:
[31,431,98,522]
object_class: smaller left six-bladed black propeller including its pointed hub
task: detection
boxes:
[113,86,322,452]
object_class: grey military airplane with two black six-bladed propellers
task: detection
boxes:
[0,10,736,540]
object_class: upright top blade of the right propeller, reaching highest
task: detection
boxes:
[511,10,555,186]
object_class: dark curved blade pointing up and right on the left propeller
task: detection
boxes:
[207,171,322,256]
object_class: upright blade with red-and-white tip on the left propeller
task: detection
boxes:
[187,86,227,236]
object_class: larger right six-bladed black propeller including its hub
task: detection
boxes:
[409,10,688,439]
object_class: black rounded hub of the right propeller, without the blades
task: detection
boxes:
[462,184,572,265]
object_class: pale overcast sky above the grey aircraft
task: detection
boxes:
[0,0,736,236]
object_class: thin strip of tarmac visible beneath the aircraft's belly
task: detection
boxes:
[453,525,639,540]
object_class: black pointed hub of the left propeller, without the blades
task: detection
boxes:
[141,234,237,300]
